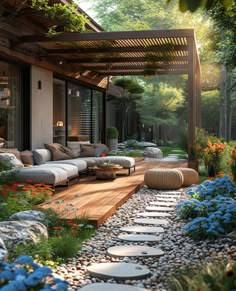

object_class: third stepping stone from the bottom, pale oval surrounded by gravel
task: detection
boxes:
[107,245,164,257]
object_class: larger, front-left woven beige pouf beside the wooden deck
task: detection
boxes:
[144,168,184,190]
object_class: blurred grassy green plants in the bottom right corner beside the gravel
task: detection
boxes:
[170,261,236,291]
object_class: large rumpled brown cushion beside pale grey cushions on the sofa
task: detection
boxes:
[44,143,74,161]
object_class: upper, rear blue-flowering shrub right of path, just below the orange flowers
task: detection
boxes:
[187,176,236,200]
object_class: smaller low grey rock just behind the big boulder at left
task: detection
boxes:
[8,210,47,225]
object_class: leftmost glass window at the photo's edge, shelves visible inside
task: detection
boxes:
[0,61,22,149]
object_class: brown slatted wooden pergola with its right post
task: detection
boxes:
[18,29,201,153]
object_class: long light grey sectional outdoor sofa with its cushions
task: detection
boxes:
[0,142,135,187]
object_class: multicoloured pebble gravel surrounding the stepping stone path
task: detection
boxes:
[56,187,236,291]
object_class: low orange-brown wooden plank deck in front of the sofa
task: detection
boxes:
[42,158,187,227]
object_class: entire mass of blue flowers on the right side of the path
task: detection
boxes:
[177,176,236,239]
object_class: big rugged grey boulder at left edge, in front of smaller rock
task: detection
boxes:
[0,220,48,251]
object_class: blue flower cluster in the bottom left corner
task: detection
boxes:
[0,256,68,291]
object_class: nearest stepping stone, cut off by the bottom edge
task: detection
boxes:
[80,283,148,291]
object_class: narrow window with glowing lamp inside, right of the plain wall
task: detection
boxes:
[53,79,66,145]
